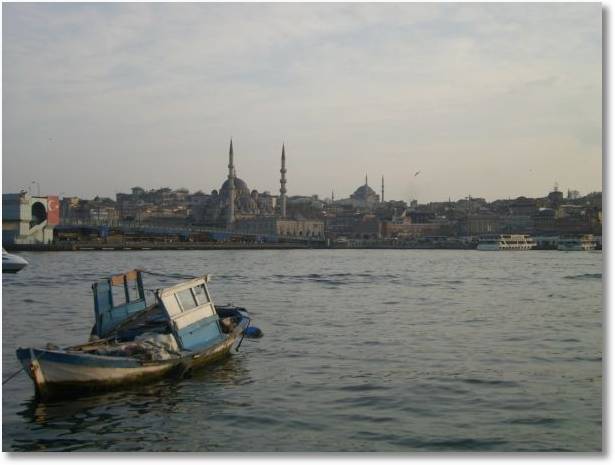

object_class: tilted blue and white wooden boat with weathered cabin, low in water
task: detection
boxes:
[17,270,262,397]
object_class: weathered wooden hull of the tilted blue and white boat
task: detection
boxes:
[17,321,248,398]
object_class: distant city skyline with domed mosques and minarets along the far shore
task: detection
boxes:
[3,141,602,244]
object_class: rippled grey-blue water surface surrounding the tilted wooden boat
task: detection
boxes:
[2,250,603,451]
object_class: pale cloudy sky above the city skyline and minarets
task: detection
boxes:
[2,3,602,202]
